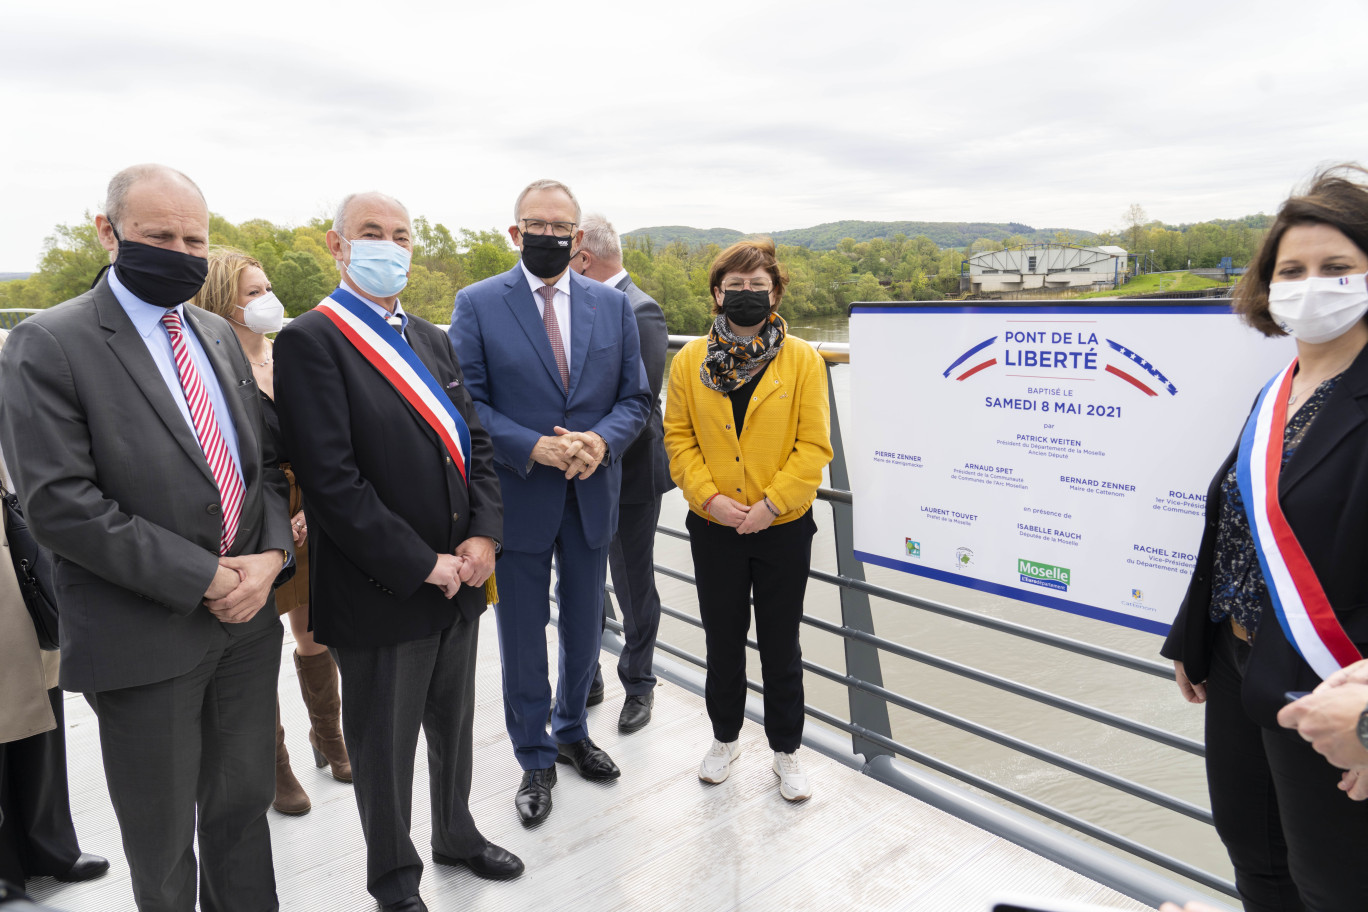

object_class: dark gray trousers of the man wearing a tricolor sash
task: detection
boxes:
[332,617,488,905]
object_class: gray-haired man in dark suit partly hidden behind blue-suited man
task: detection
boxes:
[570,215,674,732]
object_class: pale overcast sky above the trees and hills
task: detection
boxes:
[0,0,1368,272]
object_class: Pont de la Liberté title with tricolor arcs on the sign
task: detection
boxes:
[941,330,1178,397]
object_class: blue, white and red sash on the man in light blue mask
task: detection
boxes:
[315,287,471,484]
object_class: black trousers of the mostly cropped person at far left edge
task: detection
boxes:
[0,688,81,885]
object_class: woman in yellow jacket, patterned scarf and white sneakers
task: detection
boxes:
[665,239,832,801]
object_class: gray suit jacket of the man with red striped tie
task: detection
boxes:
[0,279,293,692]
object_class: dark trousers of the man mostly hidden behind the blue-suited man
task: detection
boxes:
[605,498,661,696]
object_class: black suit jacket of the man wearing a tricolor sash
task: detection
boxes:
[275,303,503,645]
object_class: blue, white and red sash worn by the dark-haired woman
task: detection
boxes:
[1235,360,1363,678]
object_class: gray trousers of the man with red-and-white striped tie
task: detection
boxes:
[86,620,285,912]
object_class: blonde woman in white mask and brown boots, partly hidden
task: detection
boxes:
[192,247,352,814]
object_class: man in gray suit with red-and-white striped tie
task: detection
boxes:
[0,165,293,912]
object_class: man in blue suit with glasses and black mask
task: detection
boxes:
[450,180,651,826]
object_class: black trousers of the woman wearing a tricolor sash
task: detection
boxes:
[1207,615,1368,912]
